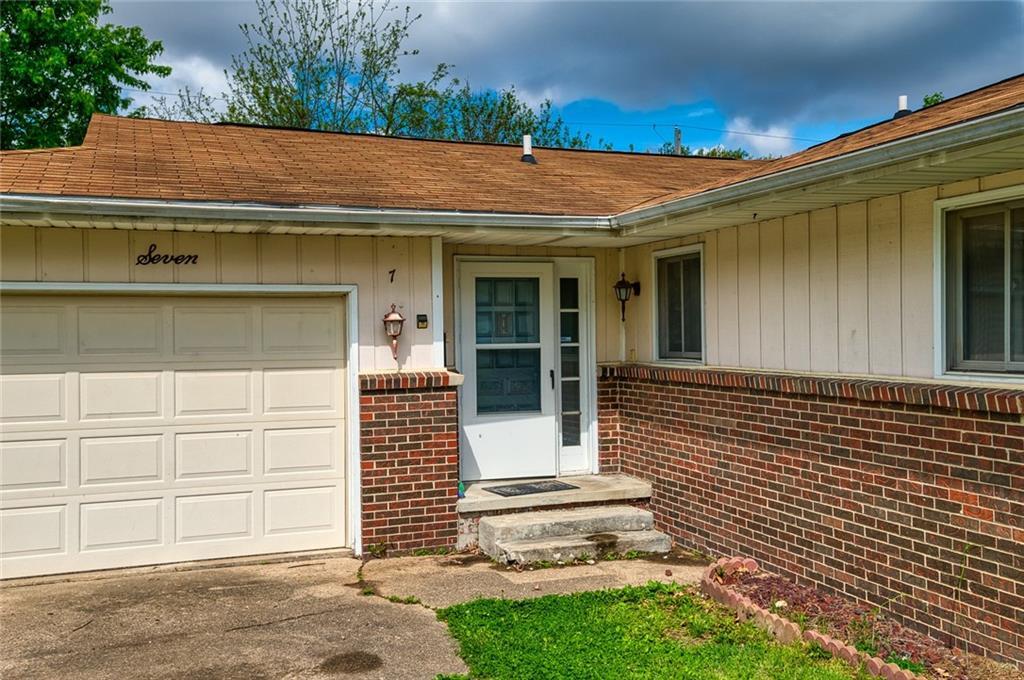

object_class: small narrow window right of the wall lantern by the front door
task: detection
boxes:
[655,250,703,360]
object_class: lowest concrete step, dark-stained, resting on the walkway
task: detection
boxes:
[497,530,672,564]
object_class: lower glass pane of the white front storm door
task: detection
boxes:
[476,349,541,414]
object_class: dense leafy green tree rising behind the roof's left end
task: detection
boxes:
[0,0,171,148]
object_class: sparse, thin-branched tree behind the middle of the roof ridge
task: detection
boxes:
[157,0,607,148]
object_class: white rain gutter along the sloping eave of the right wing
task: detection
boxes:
[614,107,1024,236]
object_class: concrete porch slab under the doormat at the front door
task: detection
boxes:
[456,474,650,513]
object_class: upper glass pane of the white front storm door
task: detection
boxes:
[476,278,541,345]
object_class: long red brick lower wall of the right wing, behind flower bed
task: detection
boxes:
[598,367,1024,665]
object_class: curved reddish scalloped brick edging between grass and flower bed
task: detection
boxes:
[700,557,921,680]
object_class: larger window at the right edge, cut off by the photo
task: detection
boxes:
[946,201,1024,373]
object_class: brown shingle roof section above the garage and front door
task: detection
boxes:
[0,115,762,215]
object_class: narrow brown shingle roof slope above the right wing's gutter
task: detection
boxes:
[622,75,1024,209]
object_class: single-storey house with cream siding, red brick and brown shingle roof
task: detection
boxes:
[0,76,1024,662]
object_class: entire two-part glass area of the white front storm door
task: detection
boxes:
[476,278,541,414]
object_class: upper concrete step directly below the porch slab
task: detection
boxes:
[479,505,654,558]
